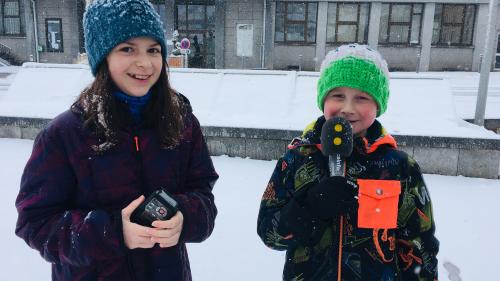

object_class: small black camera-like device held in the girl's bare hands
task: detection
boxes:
[130,189,178,227]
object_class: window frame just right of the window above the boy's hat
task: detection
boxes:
[378,3,425,47]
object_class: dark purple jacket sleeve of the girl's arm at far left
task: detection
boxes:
[15,124,125,266]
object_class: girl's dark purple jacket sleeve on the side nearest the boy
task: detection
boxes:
[173,112,219,242]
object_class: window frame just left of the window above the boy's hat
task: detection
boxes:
[273,1,319,46]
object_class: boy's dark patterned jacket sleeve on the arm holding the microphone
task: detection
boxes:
[257,150,326,250]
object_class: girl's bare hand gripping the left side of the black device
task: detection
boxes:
[122,195,155,249]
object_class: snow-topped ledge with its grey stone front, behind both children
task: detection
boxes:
[0,63,500,178]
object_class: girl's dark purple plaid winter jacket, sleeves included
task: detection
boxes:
[16,100,218,281]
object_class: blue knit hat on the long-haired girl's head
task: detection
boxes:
[83,0,167,76]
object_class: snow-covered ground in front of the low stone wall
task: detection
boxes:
[0,139,500,281]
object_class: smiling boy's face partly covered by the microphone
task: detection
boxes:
[323,87,377,136]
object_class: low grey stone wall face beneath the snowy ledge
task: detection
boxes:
[0,117,500,179]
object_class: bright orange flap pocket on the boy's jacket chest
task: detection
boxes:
[358,179,401,229]
